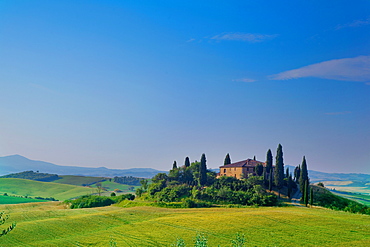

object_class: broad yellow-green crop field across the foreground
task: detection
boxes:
[0,202,370,246]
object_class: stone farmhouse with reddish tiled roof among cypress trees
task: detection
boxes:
[218,159,272,179]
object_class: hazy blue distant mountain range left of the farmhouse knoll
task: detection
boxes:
[0,155,165,178]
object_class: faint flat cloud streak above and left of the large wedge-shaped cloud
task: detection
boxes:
[211,33,279,43]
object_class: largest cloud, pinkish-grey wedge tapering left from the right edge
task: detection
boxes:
[270,56,370,82]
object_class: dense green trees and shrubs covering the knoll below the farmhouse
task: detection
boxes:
[136,151,277,207]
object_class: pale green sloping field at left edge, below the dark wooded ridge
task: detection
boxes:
[0,178,95,200]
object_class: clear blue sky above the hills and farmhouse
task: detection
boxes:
[0,0,370,173]
